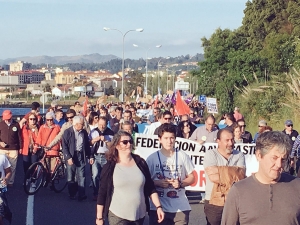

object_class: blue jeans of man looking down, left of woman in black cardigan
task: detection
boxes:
[92,154,106,196]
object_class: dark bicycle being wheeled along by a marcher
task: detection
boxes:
[23,146,67,195]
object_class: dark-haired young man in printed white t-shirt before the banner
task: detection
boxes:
[147,123,195,225]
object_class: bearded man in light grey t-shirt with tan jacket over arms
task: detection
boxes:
[203,128,246,225]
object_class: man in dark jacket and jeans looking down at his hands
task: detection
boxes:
[89,117,114,201]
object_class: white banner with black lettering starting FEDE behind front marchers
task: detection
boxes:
[135,133,258,191]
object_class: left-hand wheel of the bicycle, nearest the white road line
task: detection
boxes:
[23,162,45,195]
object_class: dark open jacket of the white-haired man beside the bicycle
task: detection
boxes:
[62,126,93,161]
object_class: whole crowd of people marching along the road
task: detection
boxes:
[0,101,300,225]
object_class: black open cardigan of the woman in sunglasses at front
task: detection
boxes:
[97,154,156,217]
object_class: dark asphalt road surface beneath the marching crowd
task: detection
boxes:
[7,158,206,225]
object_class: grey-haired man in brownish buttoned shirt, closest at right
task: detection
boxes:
[222,131,300,225]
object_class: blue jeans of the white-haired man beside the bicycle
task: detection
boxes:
[67,151,85,198]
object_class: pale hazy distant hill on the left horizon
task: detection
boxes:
[0,53,118,65]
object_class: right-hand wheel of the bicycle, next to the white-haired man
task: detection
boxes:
[52,161,68,193]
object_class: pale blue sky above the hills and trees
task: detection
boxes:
[0,0,247,59]
